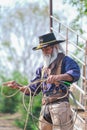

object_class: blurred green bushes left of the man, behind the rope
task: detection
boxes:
[0,71,42,130]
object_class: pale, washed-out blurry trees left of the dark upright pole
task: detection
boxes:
[0,3,49,78]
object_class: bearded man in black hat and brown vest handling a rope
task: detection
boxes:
[5,33,80,130]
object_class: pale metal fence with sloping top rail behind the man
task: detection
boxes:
[50,12,87,130]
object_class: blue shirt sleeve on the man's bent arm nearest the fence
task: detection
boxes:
[62,56,80,82]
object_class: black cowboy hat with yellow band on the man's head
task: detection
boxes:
[33,32,65,50]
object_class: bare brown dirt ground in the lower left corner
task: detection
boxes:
[0,113,22,130]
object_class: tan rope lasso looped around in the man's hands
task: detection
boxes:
[1,79,77,130]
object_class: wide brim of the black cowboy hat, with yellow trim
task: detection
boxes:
[32,40,65,50]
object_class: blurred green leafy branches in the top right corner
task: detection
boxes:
[63,0,87,34]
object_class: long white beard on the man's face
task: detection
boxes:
[43,48,58,68]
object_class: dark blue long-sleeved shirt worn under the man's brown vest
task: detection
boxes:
[29,56,80,95]
